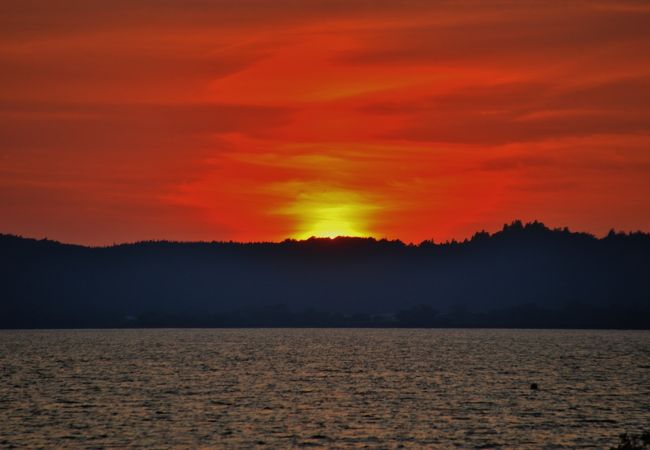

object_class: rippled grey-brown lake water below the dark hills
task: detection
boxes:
[0,329,650,448]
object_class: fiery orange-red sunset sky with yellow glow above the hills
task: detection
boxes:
[0,0,650,244]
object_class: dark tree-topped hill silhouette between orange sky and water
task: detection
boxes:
[0,221,650,329]
